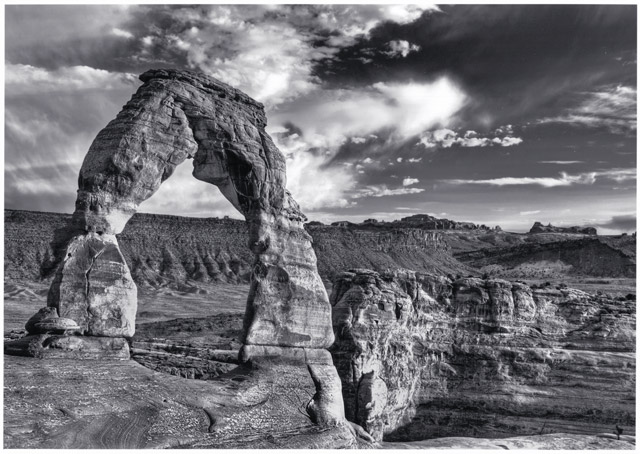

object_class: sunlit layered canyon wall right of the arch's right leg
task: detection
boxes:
[331,269,635,441]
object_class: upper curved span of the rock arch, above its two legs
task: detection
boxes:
[74,69,290,238]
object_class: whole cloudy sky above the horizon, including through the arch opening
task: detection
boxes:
[5,5,637,233]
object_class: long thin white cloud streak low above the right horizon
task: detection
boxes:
[445,169,636,188]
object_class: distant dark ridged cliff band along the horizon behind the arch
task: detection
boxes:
[10,210,636,292]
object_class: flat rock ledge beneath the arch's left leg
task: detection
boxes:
[4,334,130,360]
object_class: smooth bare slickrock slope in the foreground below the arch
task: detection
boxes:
[4,355,360,449]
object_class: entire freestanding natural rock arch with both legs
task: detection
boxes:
[13,70,344,428]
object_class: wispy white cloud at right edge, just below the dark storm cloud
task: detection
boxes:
[538,85,637,134]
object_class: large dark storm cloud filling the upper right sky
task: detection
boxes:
[317,5,636,127]
